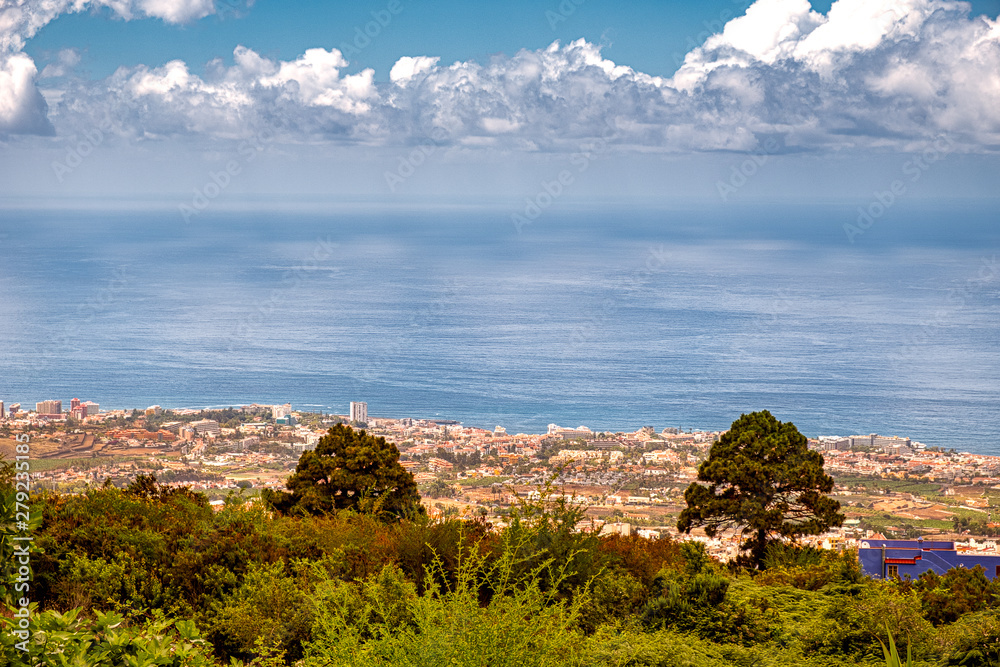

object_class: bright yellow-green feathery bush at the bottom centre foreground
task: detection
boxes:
[304,533,583,667]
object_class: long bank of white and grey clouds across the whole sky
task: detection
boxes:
[0,0,1000,152]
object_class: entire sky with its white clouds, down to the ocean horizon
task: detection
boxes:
[0,0,1000,203]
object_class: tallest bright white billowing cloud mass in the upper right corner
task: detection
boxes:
[669,0,1000,150]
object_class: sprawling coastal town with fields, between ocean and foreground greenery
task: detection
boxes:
[0,399,1000,559]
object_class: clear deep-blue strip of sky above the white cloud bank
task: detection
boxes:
[25,0,1000,80]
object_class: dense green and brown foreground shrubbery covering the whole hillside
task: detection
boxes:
[0,470,1000,667]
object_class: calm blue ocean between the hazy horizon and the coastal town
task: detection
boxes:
[0,201,1000,455]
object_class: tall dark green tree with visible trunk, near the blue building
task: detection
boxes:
[677,410,844,567]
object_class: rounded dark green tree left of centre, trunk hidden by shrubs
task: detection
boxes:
[263,424,424,518]
